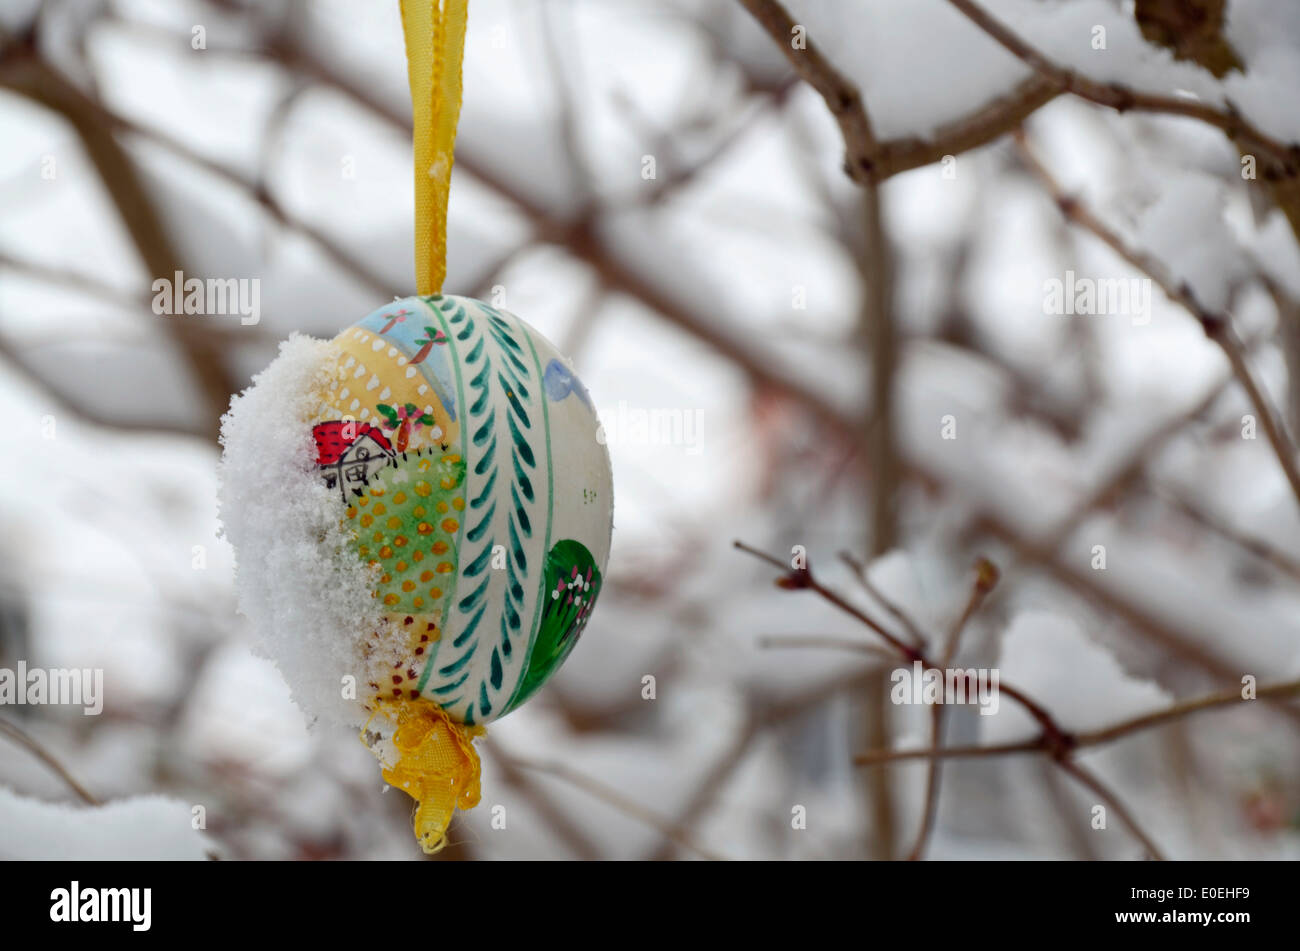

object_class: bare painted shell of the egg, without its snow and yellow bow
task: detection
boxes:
[312,296,612,725]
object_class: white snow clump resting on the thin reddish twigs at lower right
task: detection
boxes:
[979,611,1174,743]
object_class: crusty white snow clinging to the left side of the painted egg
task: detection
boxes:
[220,334,381,725]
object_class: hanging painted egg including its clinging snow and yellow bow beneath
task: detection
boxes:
[222,295,612,851]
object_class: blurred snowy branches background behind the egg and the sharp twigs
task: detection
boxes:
[0,0,1300,859]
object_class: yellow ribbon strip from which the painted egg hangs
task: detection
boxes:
[402,0,469,295]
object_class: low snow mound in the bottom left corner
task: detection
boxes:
[0,786,217,861]
